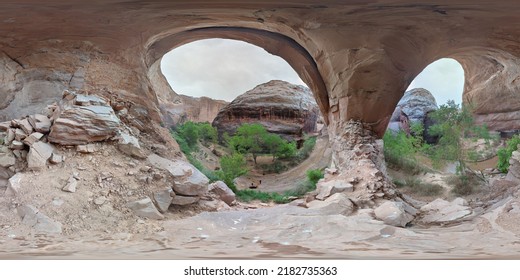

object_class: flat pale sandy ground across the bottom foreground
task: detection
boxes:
[0,192,520,259]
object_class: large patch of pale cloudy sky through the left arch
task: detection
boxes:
[161,39,305,101]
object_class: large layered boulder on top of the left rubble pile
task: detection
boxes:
[48,91,120,145]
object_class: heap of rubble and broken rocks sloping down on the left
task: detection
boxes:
[0,90,235,234]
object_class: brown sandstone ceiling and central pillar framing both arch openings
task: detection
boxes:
[0,0,520,197]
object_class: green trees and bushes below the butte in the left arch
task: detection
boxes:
[171,122,323,203]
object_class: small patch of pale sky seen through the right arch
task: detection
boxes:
[408,58,464,105]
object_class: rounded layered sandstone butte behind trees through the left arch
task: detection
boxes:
[213,80,320,141]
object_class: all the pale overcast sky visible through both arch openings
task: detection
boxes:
[161,39,464,105]
